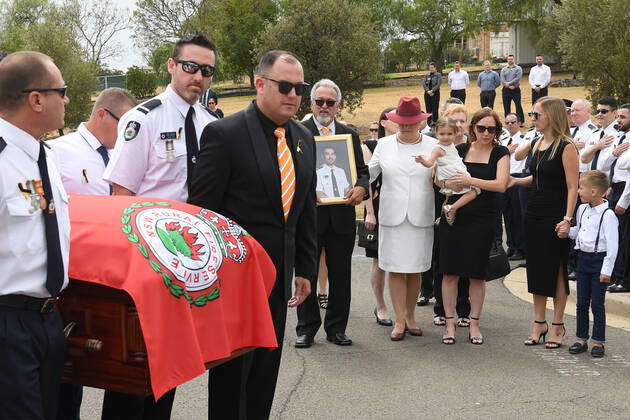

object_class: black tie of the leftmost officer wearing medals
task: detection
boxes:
[37,141,64,297]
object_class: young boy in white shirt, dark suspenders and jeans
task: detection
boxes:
[569,171,619,357]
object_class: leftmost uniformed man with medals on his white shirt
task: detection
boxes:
[0,51,70,420]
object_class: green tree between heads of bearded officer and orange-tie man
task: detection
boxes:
[215,0,277,87]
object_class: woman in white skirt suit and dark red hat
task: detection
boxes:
[368,98,437,341]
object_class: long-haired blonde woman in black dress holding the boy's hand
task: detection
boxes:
[510,97,578,349]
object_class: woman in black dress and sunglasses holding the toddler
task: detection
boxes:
[439,108,510,344]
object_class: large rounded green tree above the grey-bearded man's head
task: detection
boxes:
[258,0,381,116]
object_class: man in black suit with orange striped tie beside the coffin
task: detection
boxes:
[188,51,317,420]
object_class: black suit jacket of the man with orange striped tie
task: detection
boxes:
[188,104,318,301]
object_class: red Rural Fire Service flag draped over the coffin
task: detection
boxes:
[69,194,277,398]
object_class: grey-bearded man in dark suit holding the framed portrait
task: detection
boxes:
[295,79,370,348]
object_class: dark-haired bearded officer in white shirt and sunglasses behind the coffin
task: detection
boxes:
[102,34,217,420]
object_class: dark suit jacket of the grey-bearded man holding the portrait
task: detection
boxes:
[303,117,370,234]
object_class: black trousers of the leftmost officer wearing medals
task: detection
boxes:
[0,306,66,420]
